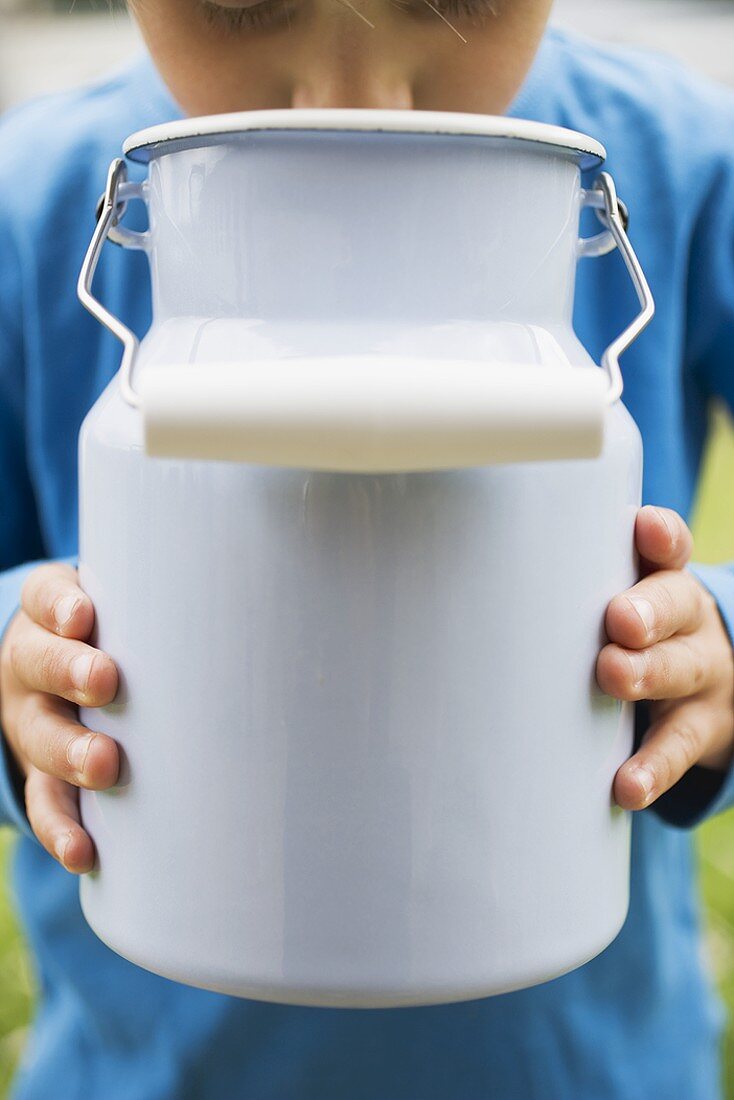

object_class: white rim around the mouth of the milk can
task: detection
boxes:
[122,107,606,169]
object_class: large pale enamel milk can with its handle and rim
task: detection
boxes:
[79,109,653,1008]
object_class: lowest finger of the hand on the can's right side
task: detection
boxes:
[614,701,731,810]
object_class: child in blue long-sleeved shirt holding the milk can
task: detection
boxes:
[0,0,734,1100]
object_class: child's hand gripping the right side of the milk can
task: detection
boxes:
[596,505,734,810]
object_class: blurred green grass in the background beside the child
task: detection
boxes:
[0,413,734,1100]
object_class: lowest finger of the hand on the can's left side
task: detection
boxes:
[25,768,95,875]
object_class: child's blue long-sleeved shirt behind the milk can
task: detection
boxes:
[0,23,734,1100]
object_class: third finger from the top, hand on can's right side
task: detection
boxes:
[596,635,716,701]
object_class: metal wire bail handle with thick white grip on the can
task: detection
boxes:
[78,161,655,472]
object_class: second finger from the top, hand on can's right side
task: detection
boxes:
[604,569,705,649]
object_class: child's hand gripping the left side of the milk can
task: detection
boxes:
[0,562,119,875]
